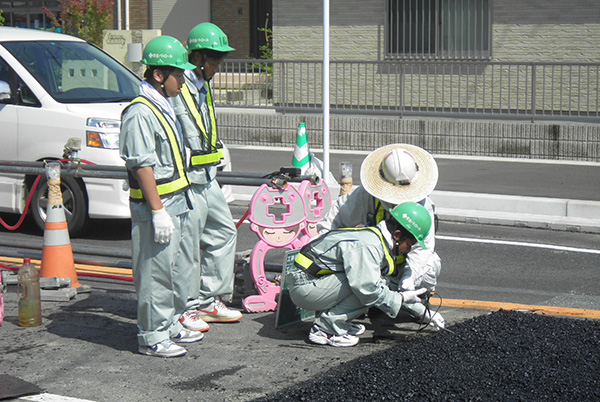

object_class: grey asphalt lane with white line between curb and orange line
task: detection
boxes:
[0,201,600,310]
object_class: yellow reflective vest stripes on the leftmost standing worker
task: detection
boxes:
[123,96,190,201]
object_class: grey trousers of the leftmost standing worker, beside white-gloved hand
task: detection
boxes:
[131,212,200,346]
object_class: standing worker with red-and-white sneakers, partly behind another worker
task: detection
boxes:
[171,22,242,330]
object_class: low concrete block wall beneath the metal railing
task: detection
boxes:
[217,108,600,162]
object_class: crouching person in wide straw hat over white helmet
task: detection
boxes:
[319,144,445,328]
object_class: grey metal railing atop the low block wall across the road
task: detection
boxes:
[214,60,600,121]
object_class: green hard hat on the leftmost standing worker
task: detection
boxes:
[142,35,196,70]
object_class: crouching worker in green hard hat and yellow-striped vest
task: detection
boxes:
[286,202,431,346]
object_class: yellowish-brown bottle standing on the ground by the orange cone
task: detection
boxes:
[17,258,42,327]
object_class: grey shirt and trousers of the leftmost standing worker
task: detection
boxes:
[119,96,199,346]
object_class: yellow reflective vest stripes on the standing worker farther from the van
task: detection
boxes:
[181,82,223,166]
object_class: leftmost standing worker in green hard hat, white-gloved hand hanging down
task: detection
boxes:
[119,36,203,357]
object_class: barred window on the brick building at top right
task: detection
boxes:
[385,0,492,59]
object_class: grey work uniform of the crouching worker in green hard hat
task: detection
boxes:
[286,223,402,335]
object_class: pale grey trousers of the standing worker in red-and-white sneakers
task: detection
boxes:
[187,180,237,310]
